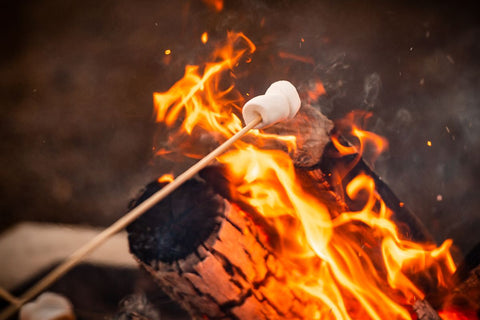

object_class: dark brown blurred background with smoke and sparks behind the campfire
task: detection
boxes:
[0,0,480,262]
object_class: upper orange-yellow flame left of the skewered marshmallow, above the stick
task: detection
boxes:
[153,33,255,137]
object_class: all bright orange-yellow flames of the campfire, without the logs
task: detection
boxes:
[154,33,455,320]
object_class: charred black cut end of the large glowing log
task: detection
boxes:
[127,179,225,263]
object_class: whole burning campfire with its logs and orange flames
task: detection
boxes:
[127,33,478,319]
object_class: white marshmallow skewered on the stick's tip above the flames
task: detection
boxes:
[242,80,301,129]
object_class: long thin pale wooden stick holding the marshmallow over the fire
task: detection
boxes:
[0,116,262,320]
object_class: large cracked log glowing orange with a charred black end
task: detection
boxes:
[127,180,324,320]
